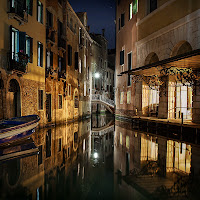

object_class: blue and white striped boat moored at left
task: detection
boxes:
[0,115,40,145]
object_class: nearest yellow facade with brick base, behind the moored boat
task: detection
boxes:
[0,0,46,124]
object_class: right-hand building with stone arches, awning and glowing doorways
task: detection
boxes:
[116,0,200,122]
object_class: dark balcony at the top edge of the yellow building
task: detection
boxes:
[8,0,28,25]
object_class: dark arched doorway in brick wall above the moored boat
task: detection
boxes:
[8,79,21,117]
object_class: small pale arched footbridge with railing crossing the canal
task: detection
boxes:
[91,94,115,113]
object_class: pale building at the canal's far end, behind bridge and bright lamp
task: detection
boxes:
[90,29,114,113]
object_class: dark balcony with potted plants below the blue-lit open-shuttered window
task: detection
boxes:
[8,52,29,74]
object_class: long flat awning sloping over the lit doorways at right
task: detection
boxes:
[118,49,200,76]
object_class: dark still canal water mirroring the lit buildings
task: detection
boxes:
[0,115,200,200]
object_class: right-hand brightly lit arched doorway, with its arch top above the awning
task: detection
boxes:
[168,41,192,119]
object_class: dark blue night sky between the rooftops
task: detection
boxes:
[69,0,115,49]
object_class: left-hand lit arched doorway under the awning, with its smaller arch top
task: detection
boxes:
[142,52,159,116]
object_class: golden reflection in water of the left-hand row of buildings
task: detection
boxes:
[0,121,91,199]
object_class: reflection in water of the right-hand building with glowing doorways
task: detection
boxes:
[114,121,197,199]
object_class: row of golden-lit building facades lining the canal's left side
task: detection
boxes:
[0,0,107,126]
